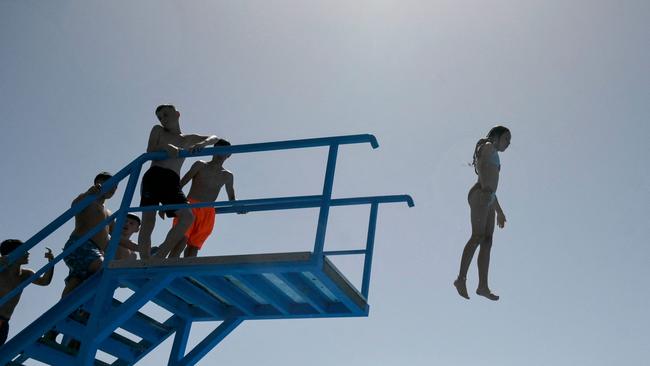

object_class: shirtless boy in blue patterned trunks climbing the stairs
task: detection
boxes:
[61,172,117,297]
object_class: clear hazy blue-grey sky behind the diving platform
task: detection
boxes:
[0,0,650,366]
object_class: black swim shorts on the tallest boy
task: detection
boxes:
[140,166,187,217]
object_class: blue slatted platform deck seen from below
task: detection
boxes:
[109,252,368,320]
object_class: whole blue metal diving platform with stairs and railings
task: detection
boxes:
[0,135,413,366]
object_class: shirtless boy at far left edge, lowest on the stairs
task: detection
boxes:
[0,239,54,346]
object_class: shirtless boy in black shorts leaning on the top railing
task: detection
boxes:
[138,104,220,259]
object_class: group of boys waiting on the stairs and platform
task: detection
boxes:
[0,104,238,348]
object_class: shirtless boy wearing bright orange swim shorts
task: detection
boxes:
[170,140,244,257]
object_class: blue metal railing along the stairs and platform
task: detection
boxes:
[0,134,413,312]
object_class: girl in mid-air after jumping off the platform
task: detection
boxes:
[454,126,512,300]
